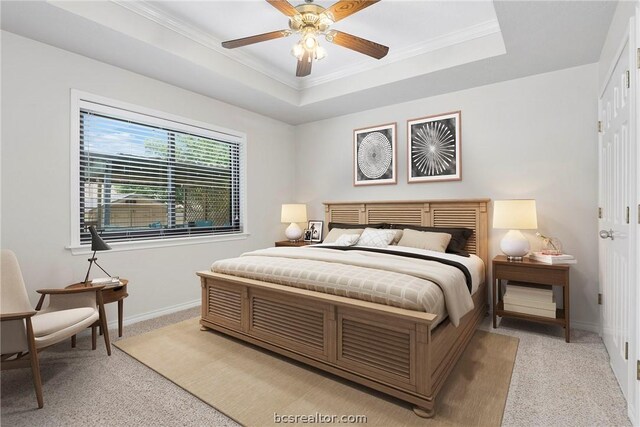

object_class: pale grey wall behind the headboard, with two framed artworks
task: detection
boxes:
[296,64,598,330]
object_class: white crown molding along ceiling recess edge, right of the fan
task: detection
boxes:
[300,19,501,89]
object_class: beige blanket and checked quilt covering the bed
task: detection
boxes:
[211,247,473,326]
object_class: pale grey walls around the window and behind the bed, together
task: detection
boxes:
[1,32,598,329]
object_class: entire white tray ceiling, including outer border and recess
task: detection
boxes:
[0,0,615,124]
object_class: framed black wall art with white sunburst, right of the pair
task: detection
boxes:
[407,111,462,183]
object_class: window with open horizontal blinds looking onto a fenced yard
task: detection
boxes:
[72,92,244,246]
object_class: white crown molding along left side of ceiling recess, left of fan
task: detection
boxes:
[109,0,301,90]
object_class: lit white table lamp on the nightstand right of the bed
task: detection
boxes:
[493,200,538,261]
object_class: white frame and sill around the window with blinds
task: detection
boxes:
[66,89,250,255]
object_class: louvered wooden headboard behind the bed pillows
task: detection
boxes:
[324,199,490,266]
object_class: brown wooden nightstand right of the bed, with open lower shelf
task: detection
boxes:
[491,255,571,342]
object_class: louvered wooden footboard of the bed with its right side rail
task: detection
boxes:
[198,271,487,416]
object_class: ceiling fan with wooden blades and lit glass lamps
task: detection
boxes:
[222,0,389,77]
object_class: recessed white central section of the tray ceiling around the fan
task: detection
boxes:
[148,0,500,88]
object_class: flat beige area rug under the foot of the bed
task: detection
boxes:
[115,318,518,427]
